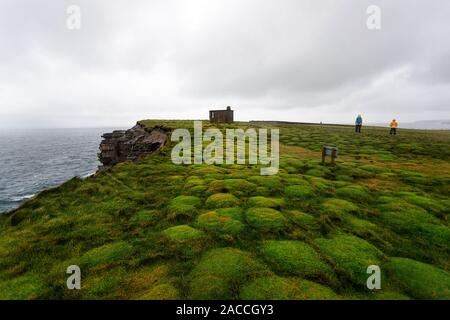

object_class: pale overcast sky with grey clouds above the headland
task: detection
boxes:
[0,0,450,128]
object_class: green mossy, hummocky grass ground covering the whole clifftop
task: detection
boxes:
[0,121,450,299]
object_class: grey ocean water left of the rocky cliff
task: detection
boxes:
[0,128,113,213]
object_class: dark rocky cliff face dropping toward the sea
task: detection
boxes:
[98,124,168,170]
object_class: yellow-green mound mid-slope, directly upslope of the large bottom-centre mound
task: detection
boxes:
[197,211,245,236]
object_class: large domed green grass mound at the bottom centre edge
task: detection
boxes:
[190,248,268,299]
